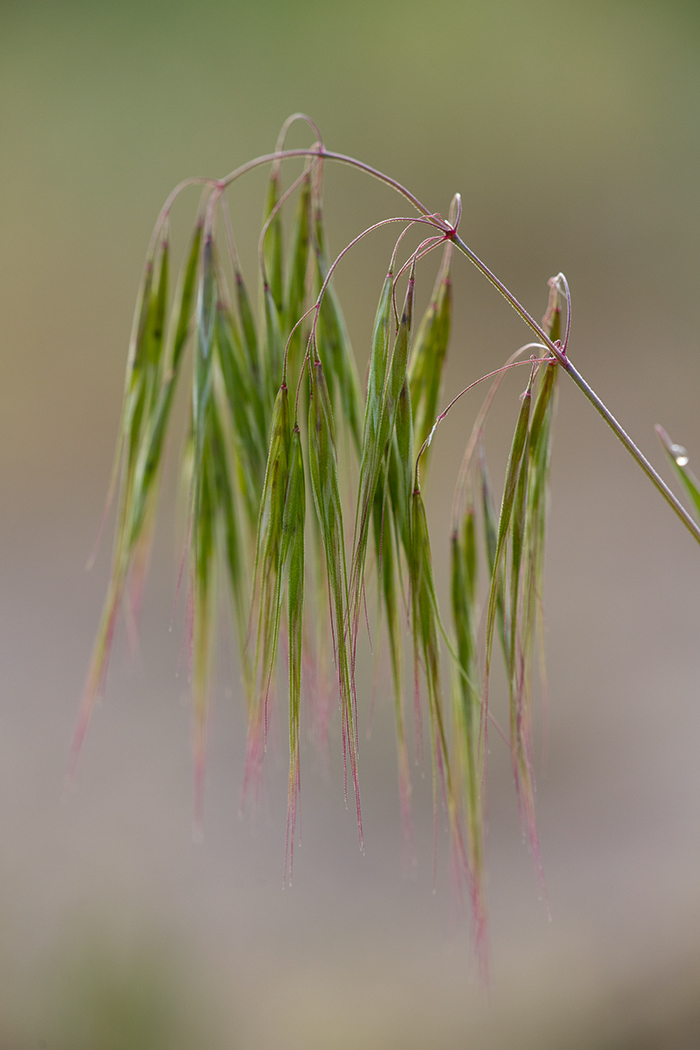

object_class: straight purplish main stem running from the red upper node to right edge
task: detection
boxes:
[451,233,700,543]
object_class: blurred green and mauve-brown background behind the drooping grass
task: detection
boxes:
[0,0,700,1050]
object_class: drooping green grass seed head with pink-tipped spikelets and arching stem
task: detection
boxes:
[71,114,700,965]
